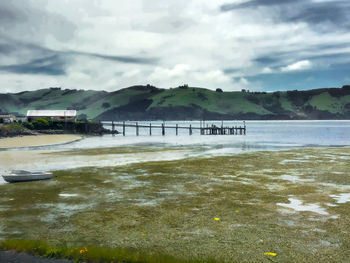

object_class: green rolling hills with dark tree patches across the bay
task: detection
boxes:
[0,85,350,120]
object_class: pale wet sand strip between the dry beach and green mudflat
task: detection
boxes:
[0,147,194,180]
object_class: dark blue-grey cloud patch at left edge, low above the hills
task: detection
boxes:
[0,55,66,76]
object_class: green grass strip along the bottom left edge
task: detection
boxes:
[0,240,217,263]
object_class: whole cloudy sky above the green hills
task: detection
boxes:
[0,0,350,93]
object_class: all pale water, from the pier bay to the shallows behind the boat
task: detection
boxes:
[0,121,350,184]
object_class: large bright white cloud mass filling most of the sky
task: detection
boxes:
[0,0,350,92]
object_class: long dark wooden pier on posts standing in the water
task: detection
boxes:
[103,121,247,136]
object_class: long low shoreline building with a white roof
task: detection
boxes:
[27,110,77,122]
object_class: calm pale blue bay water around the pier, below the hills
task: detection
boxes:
[46,121,350,154]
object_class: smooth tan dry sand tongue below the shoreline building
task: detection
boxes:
[0,134,82,149]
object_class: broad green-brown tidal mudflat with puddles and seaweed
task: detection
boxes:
[0,147,350,262]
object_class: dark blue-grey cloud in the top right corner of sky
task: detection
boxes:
[220,0,350,31]
